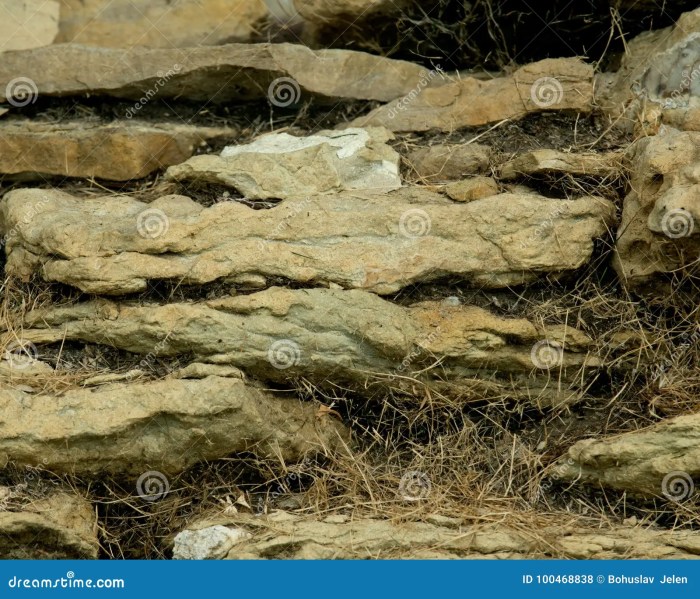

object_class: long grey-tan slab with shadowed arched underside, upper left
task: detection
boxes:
[0,44,423,106]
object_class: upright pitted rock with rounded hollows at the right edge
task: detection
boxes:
[613,127,700,289]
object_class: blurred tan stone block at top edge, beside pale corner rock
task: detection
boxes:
[56,0,267,48]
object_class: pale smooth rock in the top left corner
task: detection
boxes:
[0,0,59,52]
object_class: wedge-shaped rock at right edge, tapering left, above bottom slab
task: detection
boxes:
[551,414,700,501]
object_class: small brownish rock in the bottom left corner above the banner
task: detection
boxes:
[0,487,99,559]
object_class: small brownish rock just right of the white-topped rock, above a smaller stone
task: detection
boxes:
[407,144,491,183]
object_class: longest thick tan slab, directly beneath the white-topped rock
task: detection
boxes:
[0,189,614,294]
